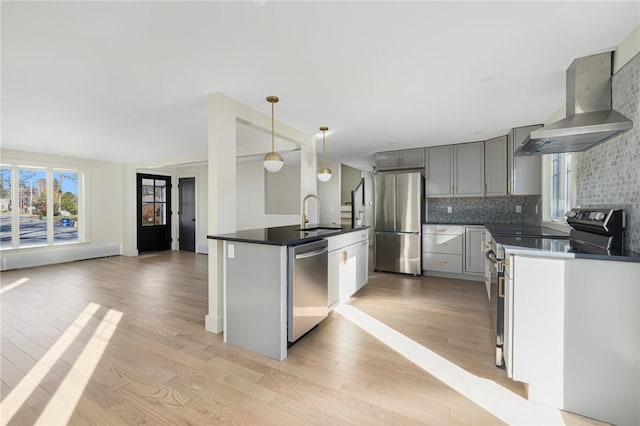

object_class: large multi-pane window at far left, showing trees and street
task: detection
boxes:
[0,165,82,250]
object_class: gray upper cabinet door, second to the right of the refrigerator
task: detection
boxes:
[453,142,484,197]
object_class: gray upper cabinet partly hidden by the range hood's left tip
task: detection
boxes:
[507,125,542,195]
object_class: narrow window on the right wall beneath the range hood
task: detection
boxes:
[543,153,575,225]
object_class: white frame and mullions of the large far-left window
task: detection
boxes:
[0,158,89,253]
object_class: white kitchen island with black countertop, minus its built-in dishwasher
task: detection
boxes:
[207,224,368,360]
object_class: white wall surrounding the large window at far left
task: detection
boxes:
[0,149,123,270]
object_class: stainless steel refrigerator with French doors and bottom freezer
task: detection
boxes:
[374,171,424,275]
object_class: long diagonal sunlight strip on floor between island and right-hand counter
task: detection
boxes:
[334,305,564,425]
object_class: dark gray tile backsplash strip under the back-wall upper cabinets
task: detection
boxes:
[427,195,541,225]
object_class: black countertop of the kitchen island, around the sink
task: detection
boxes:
[207,223,369,246]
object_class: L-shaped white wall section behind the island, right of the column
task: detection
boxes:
[236,160,300,229]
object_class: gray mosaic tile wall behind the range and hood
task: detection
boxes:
[576,54,640,252]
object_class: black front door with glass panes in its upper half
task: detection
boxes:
[137,173,171,253]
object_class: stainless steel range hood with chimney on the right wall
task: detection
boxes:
[515,52,633,155]
